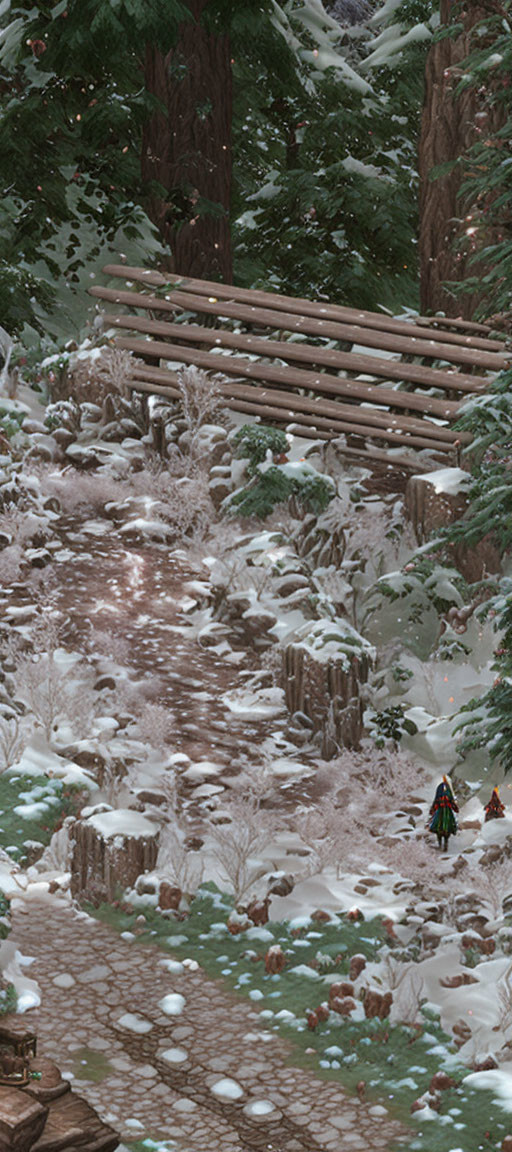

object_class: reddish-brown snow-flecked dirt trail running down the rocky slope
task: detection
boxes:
[5,520,283,774]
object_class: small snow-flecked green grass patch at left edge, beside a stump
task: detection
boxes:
[0,773,80,863]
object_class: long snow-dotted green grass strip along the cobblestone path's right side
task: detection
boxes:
[86,884,510,1152]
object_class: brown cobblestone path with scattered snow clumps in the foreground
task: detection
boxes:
[12,900,409,1152]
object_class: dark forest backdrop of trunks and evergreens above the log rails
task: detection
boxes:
[0,0,512,350]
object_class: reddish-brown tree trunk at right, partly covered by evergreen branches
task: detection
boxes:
[419,0,500,319]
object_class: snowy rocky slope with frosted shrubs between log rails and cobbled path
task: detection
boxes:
[0,373,512,1147]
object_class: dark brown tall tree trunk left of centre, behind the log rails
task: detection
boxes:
[142,0,233,283]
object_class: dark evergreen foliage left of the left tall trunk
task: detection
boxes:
[0,0,177,333]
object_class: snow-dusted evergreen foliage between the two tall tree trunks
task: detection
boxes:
[234,0,436,309]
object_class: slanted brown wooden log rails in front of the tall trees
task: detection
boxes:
[90,265,512,460]
